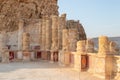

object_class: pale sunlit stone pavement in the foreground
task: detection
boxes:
[0,61,102,80]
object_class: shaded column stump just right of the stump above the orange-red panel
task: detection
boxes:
[86,39,94,53]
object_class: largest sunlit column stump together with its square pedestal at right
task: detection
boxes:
[96,36,113,80]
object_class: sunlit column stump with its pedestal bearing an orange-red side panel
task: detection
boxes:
[74,40,87,71]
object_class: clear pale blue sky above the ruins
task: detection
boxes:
[58,0,120,38]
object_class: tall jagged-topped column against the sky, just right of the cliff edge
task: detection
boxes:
[58,14,66,50]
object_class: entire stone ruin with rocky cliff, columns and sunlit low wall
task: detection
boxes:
[0,0,120,80]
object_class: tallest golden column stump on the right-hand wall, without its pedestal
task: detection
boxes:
[98,36,109,56]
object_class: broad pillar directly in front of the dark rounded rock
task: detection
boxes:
[69,29,79,52]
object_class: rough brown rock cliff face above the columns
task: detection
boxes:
[0,0,58,31]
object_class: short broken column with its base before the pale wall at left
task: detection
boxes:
[23,33,30,61]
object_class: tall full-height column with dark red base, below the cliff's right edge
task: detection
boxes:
[51,15,58,61]
